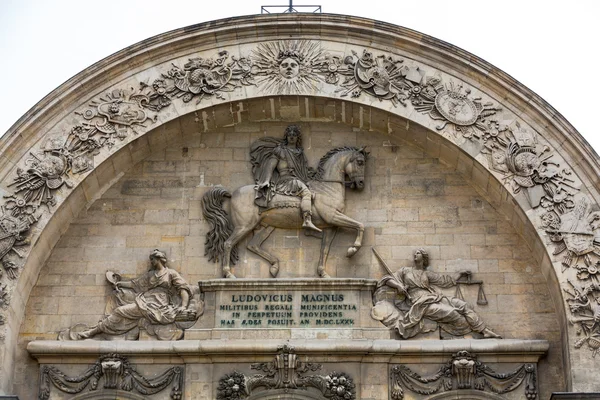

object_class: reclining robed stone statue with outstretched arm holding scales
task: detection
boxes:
[371,249,500,339]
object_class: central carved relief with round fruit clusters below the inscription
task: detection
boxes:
[216,345,357,400]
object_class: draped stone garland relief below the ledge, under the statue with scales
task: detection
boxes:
[390,350,538,400]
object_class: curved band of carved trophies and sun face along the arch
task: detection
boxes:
[0,40,600,352]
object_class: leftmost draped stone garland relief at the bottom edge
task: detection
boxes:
[38,353,184,400]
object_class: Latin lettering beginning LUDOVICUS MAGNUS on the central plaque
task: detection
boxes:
[217,292,358,329]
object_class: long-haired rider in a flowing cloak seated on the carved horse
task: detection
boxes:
[250,125,321,232]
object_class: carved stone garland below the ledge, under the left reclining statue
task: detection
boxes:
[38,353,183,400]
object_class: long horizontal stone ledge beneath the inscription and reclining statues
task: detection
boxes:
[27,339,549,363]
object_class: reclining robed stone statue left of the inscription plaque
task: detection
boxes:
[58,250,204,340]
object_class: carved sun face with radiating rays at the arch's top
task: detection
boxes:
[251,40,324,94]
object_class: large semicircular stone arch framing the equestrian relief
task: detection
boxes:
[0,15,600,392]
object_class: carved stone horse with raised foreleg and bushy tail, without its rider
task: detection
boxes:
[202,147,369,278]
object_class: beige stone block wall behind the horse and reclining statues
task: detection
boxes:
[15,122,565,399]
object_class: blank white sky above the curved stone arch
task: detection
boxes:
[0,0,600,152]
